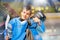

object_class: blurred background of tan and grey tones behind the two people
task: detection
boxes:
[0,0,60,40]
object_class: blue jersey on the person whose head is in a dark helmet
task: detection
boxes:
[29,19,45,40]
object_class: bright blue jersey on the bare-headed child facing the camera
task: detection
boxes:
[9,18,28,40]
